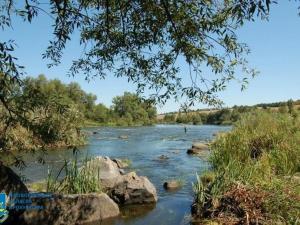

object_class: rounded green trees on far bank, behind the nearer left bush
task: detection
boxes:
[22,75,156,126]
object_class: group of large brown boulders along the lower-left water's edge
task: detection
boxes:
[0,156,158,225]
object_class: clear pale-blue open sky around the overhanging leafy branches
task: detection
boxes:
[0,1,300,112]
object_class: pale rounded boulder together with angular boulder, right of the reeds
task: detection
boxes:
[88,157,157,205]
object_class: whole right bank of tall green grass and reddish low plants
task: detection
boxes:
[192,111,300,224]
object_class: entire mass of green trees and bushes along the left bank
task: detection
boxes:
[0,74,156,158]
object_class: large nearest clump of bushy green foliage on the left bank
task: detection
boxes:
[0,75,84,150]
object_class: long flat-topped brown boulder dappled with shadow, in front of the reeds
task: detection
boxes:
[23,193,120,225]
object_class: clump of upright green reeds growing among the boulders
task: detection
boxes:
[46,155,101,194]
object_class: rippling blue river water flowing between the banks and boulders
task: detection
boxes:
[18,125,230,225]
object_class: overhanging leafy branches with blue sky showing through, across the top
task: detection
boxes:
[0,0,278,109]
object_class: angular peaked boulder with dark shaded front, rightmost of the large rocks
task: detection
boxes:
[110,172,157,205]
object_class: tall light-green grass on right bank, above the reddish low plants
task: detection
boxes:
[212,111,300,175]
